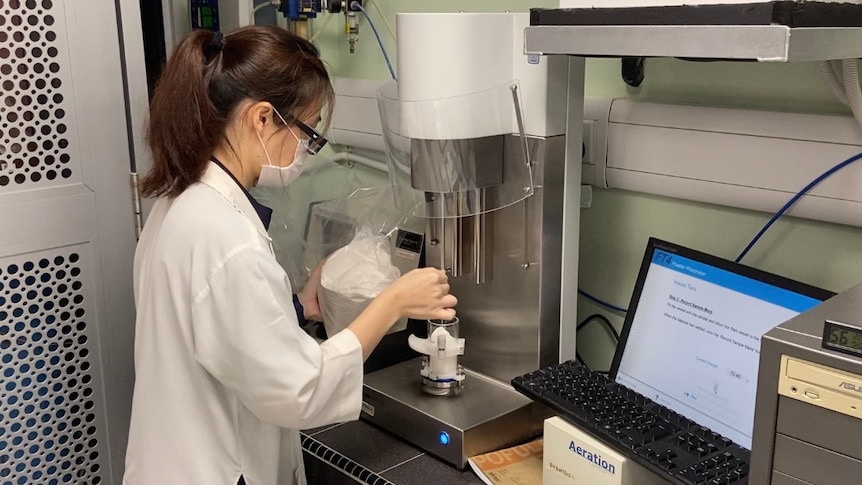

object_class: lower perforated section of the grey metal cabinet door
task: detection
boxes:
[0,247,107,485]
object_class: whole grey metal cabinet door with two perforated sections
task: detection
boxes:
[0,0,140,485]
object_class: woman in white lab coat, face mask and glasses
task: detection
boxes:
[124,27,456,485]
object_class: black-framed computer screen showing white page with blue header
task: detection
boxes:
[611,238,833,449]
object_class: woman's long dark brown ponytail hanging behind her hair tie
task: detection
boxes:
[141,30,226,197]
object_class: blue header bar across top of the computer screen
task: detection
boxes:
[652,249,820,313]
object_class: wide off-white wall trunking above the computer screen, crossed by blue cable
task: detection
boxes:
[596,99,862,226]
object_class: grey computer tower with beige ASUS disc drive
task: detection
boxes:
[750,285,862,485]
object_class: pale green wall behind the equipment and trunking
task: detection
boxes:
[308,0,862,368]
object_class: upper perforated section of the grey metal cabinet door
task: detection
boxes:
[0,0,81,192]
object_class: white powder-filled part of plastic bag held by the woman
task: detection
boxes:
[320,225,406,337]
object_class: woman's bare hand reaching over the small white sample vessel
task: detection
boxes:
[380,268,458,320]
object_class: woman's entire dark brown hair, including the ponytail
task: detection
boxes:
[141,26,334,197]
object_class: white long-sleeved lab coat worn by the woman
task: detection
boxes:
[123,163,362,485]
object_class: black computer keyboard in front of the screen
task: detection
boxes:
[512,361,749,485]
